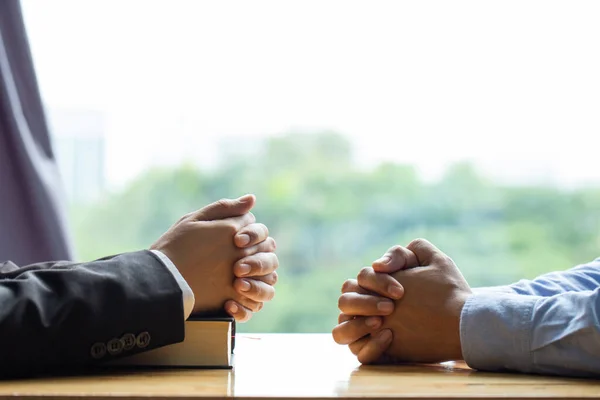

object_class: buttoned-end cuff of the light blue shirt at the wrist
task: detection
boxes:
[460,291,541,372]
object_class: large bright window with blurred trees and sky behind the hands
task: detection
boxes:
[23,0,600,332]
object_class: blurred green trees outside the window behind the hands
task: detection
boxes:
[72,132,600,332]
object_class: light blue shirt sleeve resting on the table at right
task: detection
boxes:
[460,259,600,376]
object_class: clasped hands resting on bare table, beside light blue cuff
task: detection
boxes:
[332,239,471,364]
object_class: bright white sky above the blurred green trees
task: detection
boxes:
[23,0,600,189]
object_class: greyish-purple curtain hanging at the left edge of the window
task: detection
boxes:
[0,0,71,264]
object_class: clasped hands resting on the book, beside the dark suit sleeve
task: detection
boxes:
[150,195,279,322]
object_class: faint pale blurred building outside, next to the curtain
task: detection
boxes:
[47,109,106,203]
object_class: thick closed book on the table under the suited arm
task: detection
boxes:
[110,317,235,368]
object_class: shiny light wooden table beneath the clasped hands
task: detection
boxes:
[0,334,600,399]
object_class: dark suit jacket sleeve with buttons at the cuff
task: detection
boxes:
[0,251,184,376]
